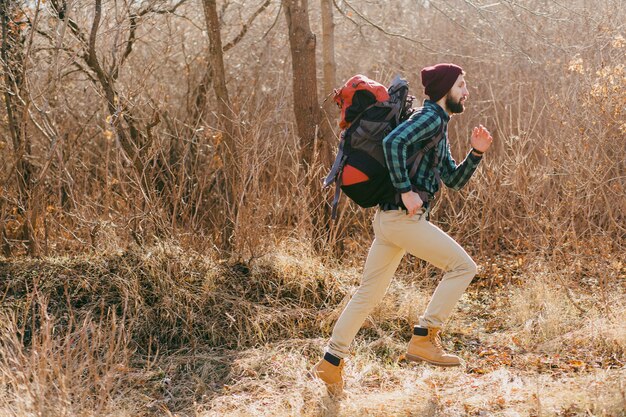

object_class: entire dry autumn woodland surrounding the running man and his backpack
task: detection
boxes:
[0,0,626,416]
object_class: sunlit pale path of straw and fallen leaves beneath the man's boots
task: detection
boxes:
[199,262,626,417]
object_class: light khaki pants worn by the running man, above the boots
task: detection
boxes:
[327,210,476,358]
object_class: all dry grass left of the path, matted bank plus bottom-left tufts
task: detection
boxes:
[0,243,345,415]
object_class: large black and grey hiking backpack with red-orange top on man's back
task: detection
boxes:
[324,74,443,219]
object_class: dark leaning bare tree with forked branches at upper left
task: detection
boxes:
[38,0,193,235]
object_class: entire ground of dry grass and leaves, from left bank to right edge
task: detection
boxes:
[0,242,626,417]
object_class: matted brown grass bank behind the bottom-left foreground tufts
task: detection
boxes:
[0,240,344,354]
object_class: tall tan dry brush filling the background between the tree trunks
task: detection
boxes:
[0,0,626,259]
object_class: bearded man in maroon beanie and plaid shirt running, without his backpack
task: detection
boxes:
[313,64,492,394]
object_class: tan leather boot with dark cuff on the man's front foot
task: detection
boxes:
[406,327,461,366]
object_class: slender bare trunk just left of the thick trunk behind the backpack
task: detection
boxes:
[202,0,237,251]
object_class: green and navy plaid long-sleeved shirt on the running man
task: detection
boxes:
[383,100,482,196]
